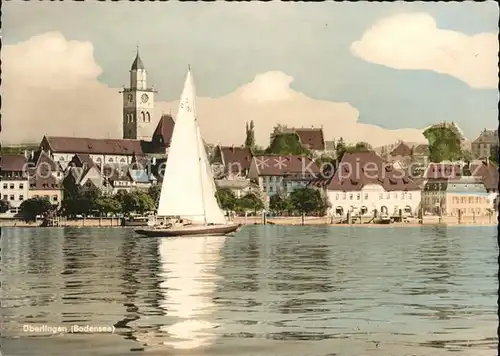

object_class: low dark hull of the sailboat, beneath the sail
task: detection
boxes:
[135,224,241,237]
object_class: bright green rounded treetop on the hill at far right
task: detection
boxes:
[423,126,463,163]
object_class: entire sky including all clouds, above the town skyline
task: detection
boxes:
[1,1,498,145]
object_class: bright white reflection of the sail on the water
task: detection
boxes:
[158,236,225,349]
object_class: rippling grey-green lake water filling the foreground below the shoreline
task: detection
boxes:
[1,226,498,356]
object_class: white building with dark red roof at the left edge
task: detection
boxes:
[0,155,29,214]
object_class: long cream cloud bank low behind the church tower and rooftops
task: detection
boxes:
[1,33,425,146]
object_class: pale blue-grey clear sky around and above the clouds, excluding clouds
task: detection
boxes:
[2,2,498,142]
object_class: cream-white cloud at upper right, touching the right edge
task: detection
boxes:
[351,13,498,88]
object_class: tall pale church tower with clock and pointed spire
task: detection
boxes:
[120,48,156,141]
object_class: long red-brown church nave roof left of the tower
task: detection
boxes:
[42,136,144,155]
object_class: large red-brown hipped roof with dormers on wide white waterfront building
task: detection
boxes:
[327,151,419,191]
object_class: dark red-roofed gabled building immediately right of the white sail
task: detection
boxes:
[212,145,253,179]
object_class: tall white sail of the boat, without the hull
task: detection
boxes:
[158,70,226,224]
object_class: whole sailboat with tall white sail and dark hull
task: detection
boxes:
[135,68,241,237]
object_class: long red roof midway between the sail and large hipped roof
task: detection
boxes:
[252,155,320,176]
